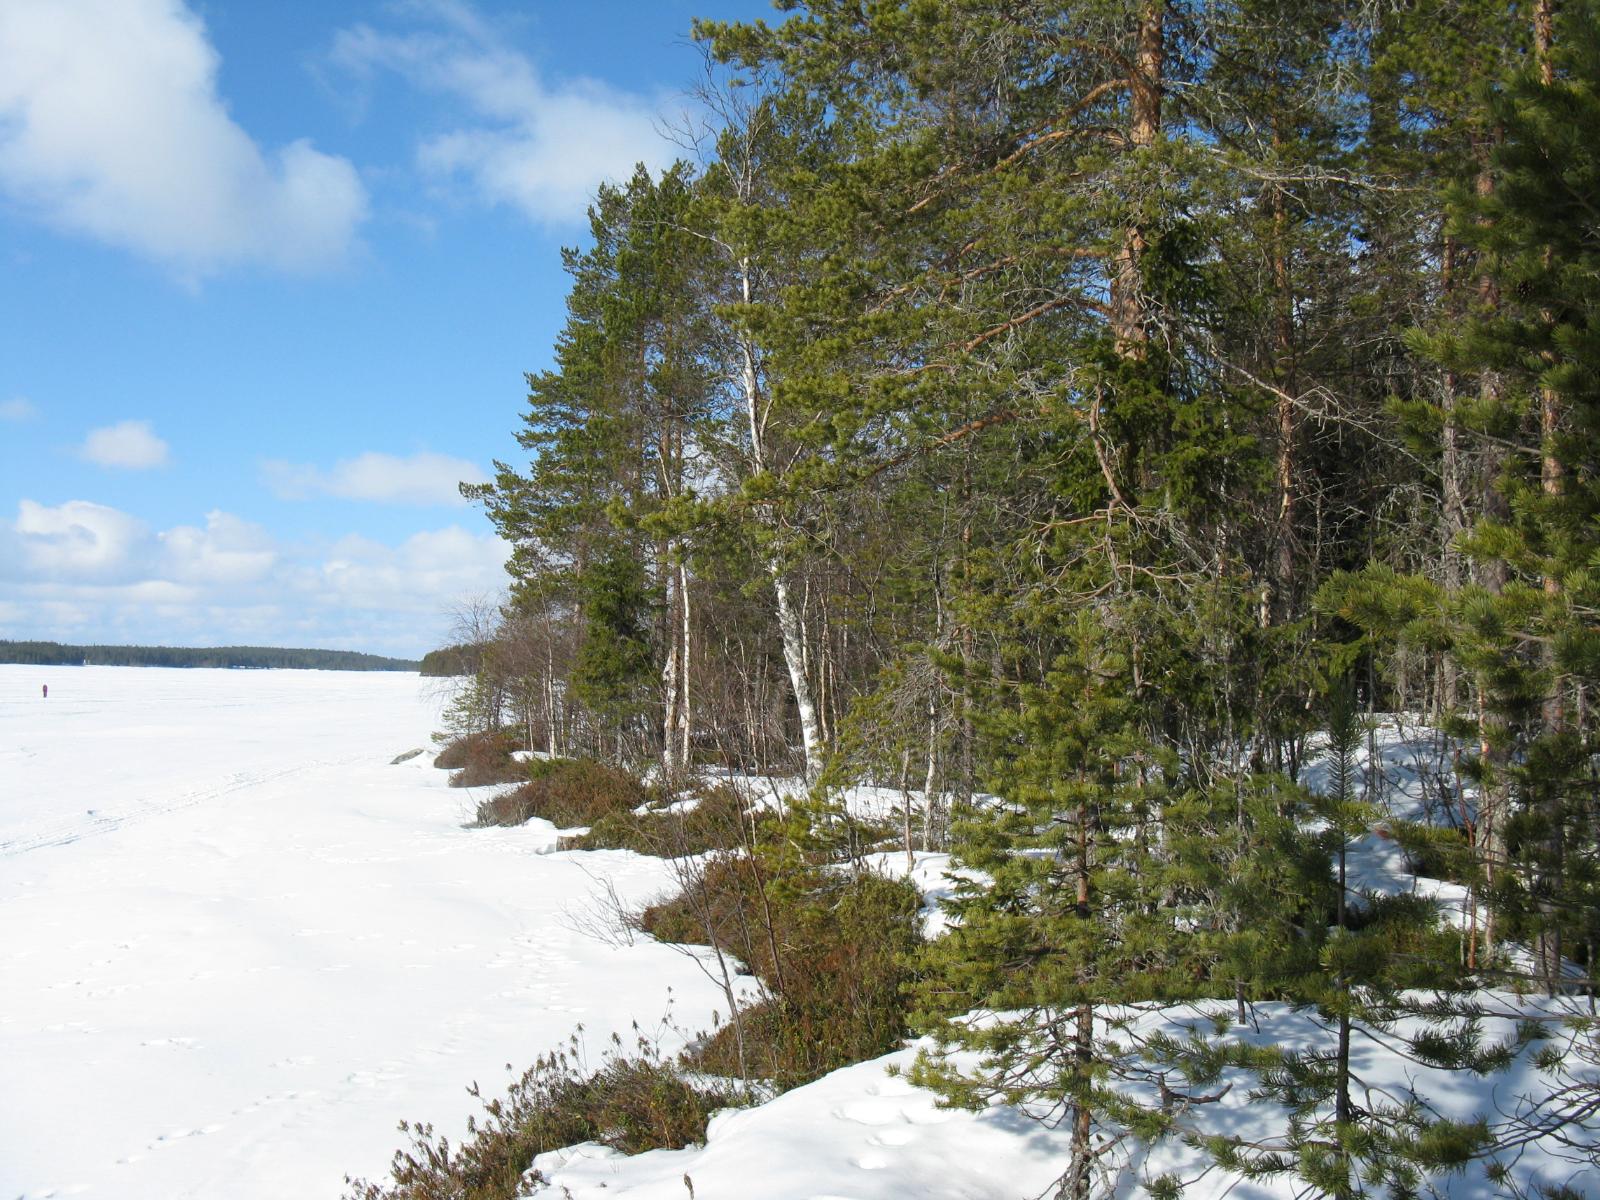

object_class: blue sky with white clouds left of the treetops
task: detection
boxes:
[0,0,771,654]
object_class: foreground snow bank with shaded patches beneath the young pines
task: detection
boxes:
[533,997,1600,1200]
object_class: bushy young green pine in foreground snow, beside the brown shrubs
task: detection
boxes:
[915,616,1194,1200]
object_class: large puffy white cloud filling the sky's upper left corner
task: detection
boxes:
[0,0,366,278]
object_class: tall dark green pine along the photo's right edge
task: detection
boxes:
[1446,2,1600,994]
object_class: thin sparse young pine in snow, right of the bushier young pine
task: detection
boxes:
[1176,680,1512,1200]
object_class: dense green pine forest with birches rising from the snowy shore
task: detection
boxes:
[419,0,1600,1200]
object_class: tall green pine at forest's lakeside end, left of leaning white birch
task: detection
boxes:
[466,166,722,768]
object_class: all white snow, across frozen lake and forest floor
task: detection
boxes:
[0,678,1600,1200]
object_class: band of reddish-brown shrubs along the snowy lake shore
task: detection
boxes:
[346,764,920,1200]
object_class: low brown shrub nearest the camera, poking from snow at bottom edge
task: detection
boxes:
[346,1038,750,1200]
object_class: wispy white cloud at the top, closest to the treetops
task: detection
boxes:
[333,0,674,224]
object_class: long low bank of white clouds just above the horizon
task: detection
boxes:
[0,501,507,656]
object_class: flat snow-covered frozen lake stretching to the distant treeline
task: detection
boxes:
[0,666,732,1200]
